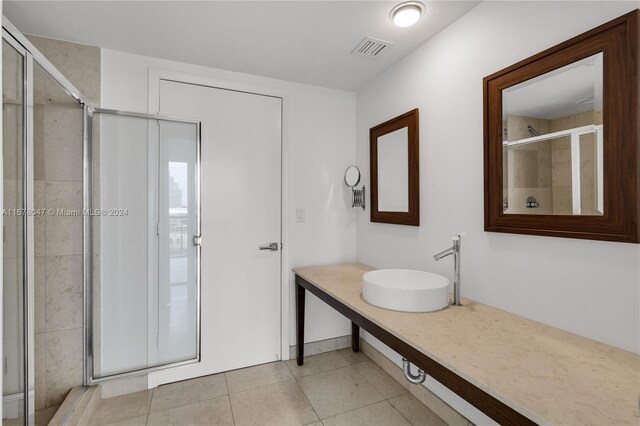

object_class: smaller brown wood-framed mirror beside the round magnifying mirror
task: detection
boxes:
[369,109,420,226]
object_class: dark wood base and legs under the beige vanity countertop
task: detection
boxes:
[296,274,536,425]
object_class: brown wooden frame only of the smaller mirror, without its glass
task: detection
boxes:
[369,108,420,226]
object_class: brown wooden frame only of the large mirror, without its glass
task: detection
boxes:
[483,10,640,243]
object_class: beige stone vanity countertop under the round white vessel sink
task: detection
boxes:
[294,264,640,425]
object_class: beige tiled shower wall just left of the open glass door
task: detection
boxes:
[28,36,100,410]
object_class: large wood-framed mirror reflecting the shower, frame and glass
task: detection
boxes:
[483,10,640,243]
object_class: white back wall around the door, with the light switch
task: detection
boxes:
[101,49,358,357]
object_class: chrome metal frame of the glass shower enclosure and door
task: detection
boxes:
[2,15,201,396]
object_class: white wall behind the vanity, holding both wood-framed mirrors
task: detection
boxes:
[357,2,640,420]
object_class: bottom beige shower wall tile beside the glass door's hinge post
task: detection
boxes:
[46,328,83,406]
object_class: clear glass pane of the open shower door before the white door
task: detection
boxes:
[90,109,200,381]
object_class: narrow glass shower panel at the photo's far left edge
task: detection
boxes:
[2,36,34,424]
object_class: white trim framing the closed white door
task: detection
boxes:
[148,67,291,389]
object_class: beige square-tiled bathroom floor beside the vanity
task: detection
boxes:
[90,349,446,426]
